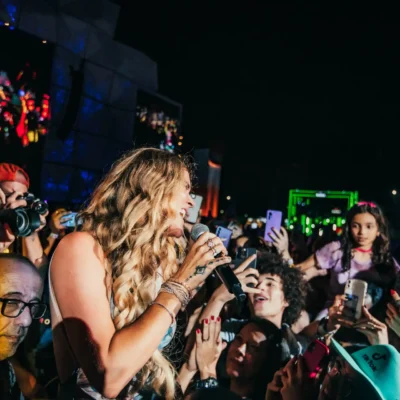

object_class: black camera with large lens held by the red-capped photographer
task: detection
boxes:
[0,193,48,237]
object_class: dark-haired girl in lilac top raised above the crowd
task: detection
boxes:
[297,202,399,319]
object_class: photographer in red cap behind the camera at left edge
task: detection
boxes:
[0,163,48,272]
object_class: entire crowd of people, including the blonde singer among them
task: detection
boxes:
[0,148,400,400]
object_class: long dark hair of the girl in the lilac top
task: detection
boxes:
[342,202,394,271]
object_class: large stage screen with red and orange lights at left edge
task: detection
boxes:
[0,25,54,193]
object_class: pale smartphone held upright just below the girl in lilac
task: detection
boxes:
[342,279,368,322]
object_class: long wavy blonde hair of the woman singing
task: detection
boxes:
[80,148,191,399]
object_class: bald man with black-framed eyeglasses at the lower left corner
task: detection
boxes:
[0,254,46,399]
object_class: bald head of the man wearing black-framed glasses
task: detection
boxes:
[0,254,43,361]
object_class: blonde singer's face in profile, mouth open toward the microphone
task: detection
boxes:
[168,169,194,237]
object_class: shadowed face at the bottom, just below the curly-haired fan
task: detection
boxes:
[226,323,268,379]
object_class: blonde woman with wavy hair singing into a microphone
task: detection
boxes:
[50,148,230,400]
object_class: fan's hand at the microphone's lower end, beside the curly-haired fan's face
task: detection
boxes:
[214,254,261,303]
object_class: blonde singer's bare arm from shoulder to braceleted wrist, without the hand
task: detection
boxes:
[51,232,181,398]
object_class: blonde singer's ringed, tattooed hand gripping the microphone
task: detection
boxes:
[173,232,232,290]
